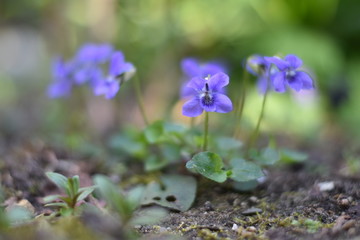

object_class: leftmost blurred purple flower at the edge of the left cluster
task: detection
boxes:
[47,58,72,98]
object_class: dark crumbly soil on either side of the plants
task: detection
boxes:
[0,137,360,239]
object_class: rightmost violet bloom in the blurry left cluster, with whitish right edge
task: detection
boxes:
[93,51,136,99]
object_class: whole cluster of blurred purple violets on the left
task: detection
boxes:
[48,43,136,99]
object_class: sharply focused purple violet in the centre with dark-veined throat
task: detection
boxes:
[182,73,233,117]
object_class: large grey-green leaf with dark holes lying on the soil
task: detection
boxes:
[141,175,197,211]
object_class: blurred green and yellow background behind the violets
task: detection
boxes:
[0,0,360,150]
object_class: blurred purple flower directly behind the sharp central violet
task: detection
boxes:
[180,58,226,97]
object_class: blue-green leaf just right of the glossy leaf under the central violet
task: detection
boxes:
[230,158,264,182]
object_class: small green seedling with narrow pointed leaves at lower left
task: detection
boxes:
[44,172,95,215]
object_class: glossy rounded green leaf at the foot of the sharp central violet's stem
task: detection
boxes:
[186,152,227,183]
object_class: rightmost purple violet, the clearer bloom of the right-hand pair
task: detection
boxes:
[264,54,314,92]
